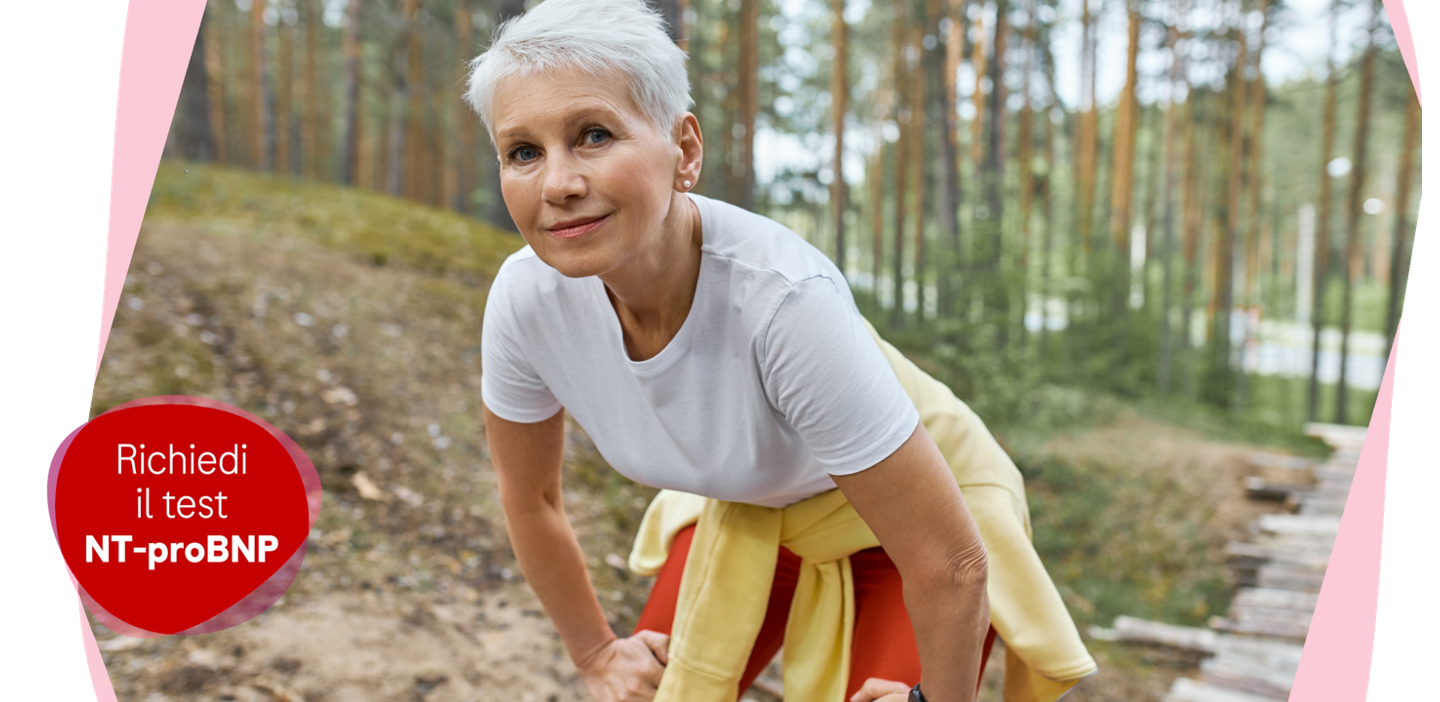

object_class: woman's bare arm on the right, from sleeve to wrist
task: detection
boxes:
[835,424,989,702]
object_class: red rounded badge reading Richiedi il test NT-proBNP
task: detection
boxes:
[48,396,320,637]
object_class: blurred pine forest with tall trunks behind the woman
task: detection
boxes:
[166,0,1420,427]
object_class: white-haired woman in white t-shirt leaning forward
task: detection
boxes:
[467,0,1093,702]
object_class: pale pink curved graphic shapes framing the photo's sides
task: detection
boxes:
[95,0,1420,702]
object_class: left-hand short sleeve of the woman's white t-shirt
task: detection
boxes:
[480,263,560,424]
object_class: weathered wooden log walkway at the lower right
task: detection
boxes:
[1092,424,1365,702]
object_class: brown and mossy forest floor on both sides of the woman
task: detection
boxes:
[92,164,1319,702]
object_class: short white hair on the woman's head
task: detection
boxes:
[465,0,694,141]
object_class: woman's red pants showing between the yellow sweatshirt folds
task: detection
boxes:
[635,525,995,699]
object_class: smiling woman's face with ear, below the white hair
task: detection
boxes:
[494,69,698,278]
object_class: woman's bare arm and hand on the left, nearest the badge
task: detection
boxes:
[484,407,668,702]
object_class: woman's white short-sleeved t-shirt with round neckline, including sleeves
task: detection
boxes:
[481,194,920,506]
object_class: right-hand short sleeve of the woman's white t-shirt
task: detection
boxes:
[759,276,920,475]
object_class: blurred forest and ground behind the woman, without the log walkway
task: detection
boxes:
[92,0,1420,702]
